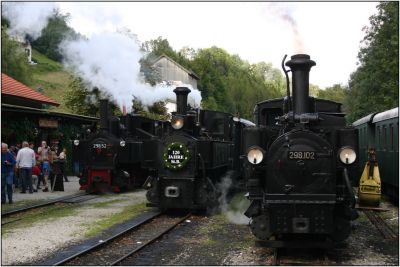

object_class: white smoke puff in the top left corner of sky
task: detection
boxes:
[2,2,56,40]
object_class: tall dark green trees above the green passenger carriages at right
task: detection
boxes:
[345,2,399,122]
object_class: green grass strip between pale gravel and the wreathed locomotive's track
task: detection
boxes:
[85,203,147,238]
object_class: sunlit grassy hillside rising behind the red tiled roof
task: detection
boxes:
[29,49,70,112]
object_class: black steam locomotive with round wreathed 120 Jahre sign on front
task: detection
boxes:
[145,87,254,210]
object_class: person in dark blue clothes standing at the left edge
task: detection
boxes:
[1,143,15,204]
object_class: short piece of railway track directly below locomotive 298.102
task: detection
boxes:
[271,248,332,266]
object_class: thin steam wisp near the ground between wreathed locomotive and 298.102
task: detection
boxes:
[216,174,250,224]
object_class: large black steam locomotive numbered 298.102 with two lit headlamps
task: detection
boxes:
[244,54,358,246]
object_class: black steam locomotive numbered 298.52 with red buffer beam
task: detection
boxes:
[73,100,165,192]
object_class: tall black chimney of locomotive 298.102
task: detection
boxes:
[285,54,315,114]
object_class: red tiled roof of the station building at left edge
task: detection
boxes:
[1,73,60,106]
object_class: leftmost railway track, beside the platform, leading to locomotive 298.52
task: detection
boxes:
[1,193,99,221]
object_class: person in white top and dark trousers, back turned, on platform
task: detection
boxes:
[17,141,36,194]
